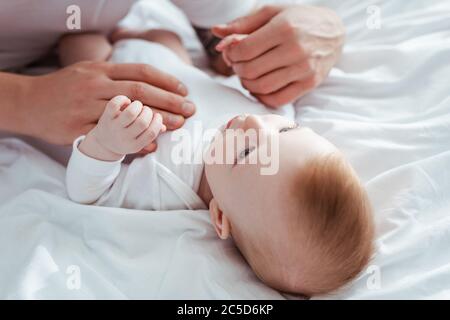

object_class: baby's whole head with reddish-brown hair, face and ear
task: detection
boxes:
[205,115,373,295]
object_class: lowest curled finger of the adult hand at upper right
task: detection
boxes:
[255,76,317,108]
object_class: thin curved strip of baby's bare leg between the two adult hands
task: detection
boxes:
[111,28,192,64]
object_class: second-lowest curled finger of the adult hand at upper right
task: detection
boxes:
[241,60,313,95]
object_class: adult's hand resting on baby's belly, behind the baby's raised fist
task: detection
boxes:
[20,62,195,146]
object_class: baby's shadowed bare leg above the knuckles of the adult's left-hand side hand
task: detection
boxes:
[58,33,112,66]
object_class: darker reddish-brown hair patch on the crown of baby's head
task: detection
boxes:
[290,154,374,294]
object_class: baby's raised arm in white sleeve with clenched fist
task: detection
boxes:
[66,96,166,204]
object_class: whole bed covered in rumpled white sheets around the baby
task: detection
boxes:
[0,0,450,299]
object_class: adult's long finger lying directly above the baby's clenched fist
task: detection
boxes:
[111,81,195,117]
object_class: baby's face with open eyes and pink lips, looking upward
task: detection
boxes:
[205,115,337,231]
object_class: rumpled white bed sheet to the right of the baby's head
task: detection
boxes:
[297,0,450,299]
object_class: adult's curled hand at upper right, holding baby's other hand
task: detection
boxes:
[212,5,345,107]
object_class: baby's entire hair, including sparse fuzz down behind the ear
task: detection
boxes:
[232,154,374,295]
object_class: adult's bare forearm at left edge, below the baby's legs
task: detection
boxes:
[0,72,33,134]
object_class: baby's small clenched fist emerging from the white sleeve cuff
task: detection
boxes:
[80,96,166,161]
